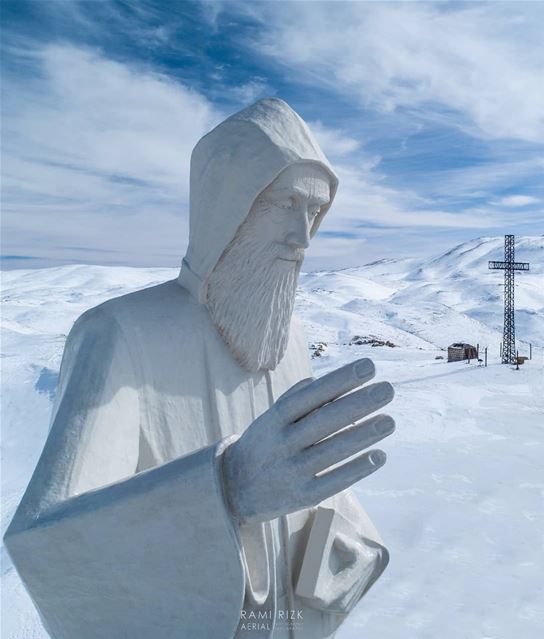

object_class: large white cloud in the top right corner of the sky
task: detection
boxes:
[252,2,544,141]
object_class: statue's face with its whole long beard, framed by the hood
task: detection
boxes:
[208,164,330,372]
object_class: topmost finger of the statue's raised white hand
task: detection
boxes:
[276,358,376,424]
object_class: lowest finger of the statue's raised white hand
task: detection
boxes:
[310,450,387,501]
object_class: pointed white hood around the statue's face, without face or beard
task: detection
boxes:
[179,98,338,304]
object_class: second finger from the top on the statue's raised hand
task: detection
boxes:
[292,382,395,448]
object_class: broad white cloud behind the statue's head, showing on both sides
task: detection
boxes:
[3,46,506,264]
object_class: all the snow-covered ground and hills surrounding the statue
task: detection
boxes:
[2,236,544,639]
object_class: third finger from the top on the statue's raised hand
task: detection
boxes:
[301,415,395,475]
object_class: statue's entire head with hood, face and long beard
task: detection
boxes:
[180,99,338,372]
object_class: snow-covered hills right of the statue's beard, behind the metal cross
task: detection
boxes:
[299,236,544,351]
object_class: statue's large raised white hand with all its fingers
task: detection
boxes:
[223,359,395,523]
